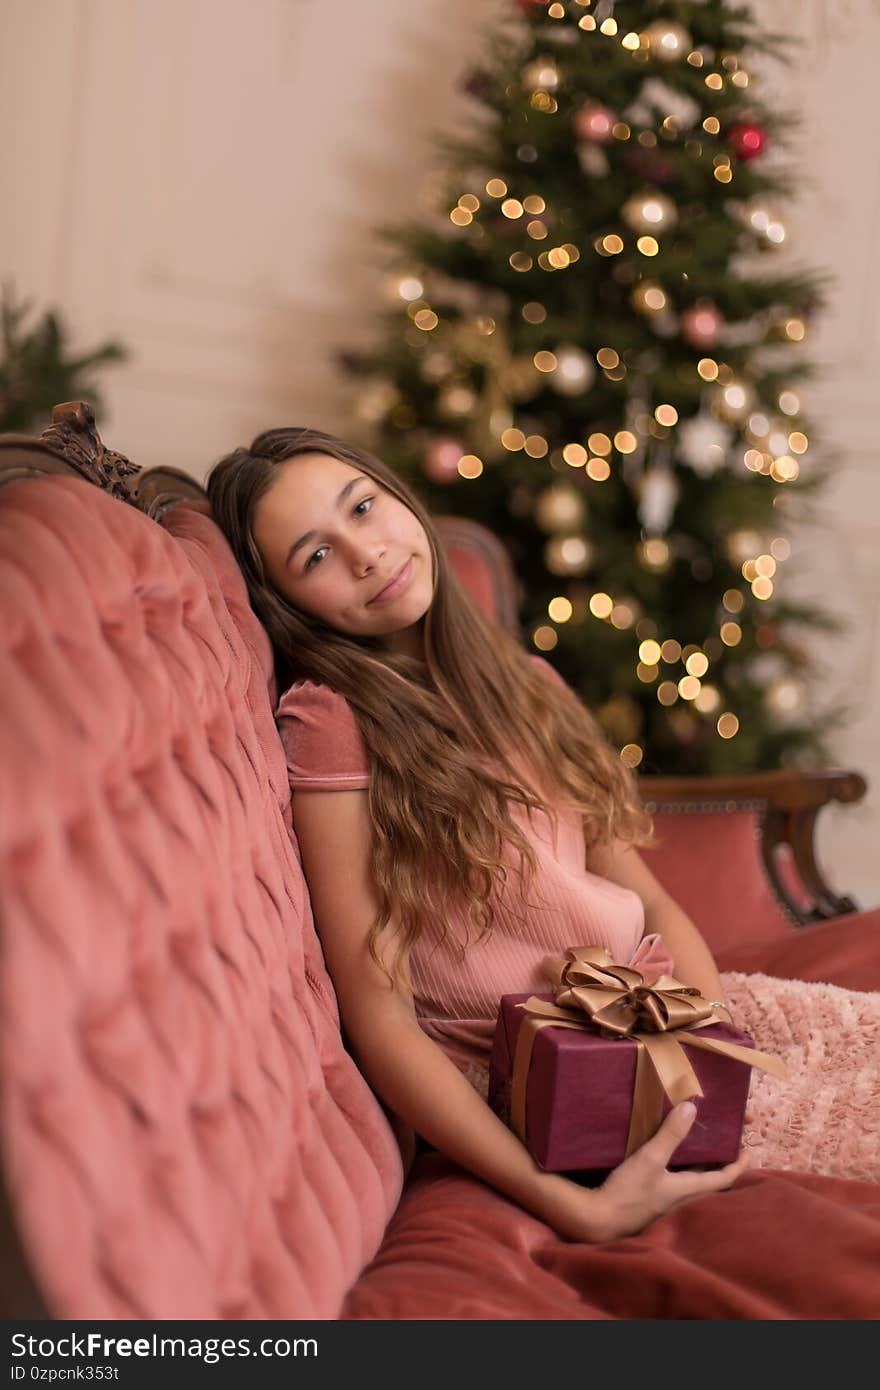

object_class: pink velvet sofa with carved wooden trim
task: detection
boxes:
[0,407,880,1319]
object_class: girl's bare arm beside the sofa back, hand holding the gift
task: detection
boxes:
[293,791,744,1241]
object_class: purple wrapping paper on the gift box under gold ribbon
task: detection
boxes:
[488,994,755,1173]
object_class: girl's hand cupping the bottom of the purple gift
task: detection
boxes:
[553,1101,748,1241]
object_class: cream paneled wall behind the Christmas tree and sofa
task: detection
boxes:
[0,0,880,905]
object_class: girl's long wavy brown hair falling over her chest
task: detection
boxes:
[206,428,652,980]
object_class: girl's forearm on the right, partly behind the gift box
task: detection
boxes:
[587,840,724,1002]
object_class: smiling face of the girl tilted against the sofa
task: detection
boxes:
[253,453,434,656]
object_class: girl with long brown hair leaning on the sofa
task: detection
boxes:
[207,428,870,1241]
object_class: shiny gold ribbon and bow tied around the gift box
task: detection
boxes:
[510,947,788,1155]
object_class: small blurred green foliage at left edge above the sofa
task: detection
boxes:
[0,285,125,434]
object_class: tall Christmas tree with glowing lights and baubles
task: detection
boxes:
[339,0,844,773]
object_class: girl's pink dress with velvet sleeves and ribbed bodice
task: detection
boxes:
[277,657,671,1095]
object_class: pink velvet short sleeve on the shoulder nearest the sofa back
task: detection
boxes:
[275,681,370,791]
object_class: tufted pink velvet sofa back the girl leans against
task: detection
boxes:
[0,477,402,1318]
